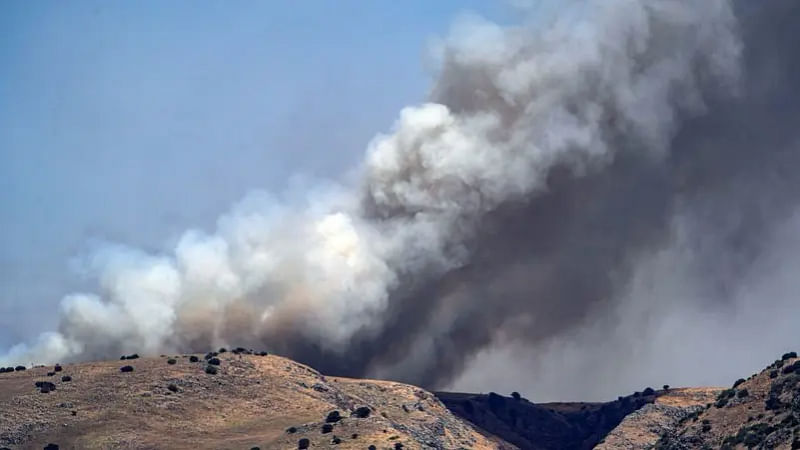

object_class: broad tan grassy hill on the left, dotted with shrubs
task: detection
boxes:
[0,352,514,449]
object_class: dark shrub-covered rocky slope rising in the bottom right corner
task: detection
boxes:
[655,353,800,450]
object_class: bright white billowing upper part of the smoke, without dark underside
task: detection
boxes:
[0,0,741,370]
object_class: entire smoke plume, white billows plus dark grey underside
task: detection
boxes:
[0,0,800,400]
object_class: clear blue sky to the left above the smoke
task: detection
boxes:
[0,0,509,348]
